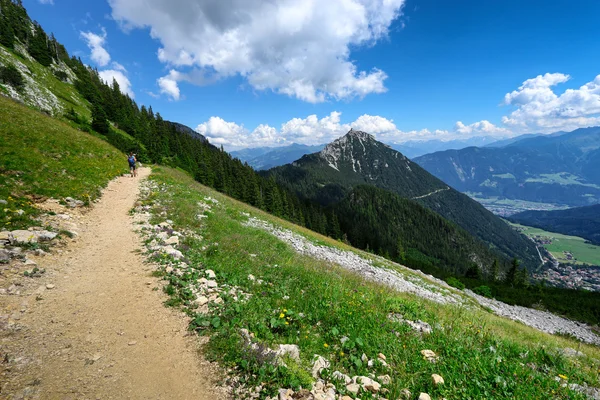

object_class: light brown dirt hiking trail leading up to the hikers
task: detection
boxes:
[0,168,228,400]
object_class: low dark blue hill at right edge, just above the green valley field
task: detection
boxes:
[509,204,600,246]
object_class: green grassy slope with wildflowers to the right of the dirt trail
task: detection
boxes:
[142,168,600,399]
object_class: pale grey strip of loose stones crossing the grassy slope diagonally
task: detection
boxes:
[246,218,600,345]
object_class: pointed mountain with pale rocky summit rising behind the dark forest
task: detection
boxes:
[264,130,539,268]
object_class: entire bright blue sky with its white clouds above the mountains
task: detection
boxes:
[24,0,600,148]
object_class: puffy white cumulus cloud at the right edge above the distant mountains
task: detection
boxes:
[502,73,600,132]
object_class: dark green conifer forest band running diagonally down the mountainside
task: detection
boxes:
[0,0,600,323]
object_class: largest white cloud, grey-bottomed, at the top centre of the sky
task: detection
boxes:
[109,0,405,103]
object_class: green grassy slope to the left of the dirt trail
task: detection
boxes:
[0,96,127,230]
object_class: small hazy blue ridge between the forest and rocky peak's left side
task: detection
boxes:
[230,143,325,171]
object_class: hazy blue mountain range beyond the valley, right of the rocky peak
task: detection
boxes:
[414,127,600,206]
